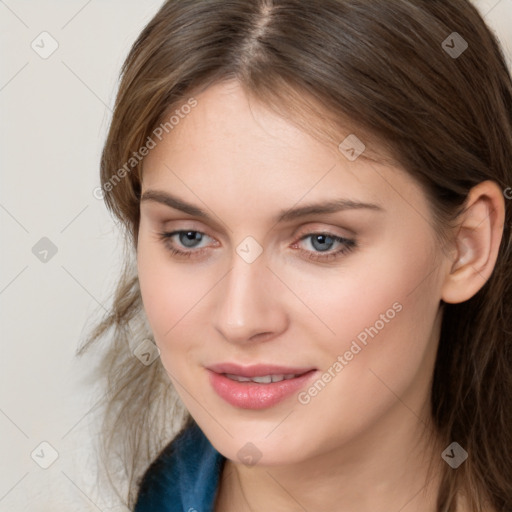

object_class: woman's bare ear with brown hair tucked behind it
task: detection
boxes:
[441,180,505,304]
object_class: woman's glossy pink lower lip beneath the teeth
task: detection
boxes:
[208,370,317,409]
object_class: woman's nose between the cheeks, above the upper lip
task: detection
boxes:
[215,247,288,344]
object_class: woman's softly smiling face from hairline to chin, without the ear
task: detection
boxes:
[137,81,450,465]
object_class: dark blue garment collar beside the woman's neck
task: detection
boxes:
[134,422,226,512]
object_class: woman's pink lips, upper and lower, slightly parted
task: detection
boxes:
[207,363,319,409]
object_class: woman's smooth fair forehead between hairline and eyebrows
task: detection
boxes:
[142,81,428,222]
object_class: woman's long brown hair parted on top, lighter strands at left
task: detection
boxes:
[79,0,512,512]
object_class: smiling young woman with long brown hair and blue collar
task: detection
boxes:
[79,0,512,512]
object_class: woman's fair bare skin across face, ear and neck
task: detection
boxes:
[137,81,504,512]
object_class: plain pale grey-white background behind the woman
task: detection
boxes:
[0,0,512,512]
